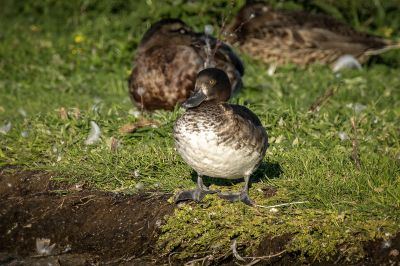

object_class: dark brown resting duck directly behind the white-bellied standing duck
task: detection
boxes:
[129,19,244,111]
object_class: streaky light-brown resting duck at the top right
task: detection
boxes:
[228,1,400,65]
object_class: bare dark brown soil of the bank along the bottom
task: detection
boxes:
[0,168,400,266]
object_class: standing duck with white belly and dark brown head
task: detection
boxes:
[174,68,268,205]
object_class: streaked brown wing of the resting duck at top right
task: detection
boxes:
[241,8,390,56]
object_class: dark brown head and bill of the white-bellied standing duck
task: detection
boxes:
[182,68,231,109]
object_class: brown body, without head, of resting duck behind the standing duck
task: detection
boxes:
[129,28,243,111]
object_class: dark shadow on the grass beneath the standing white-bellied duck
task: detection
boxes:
[191,162,283,186]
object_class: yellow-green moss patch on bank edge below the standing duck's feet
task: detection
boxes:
[158,190,399,261]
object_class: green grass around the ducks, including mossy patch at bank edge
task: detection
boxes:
[0,1,400,260]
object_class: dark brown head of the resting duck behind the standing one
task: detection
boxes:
[140,18,194,46]
